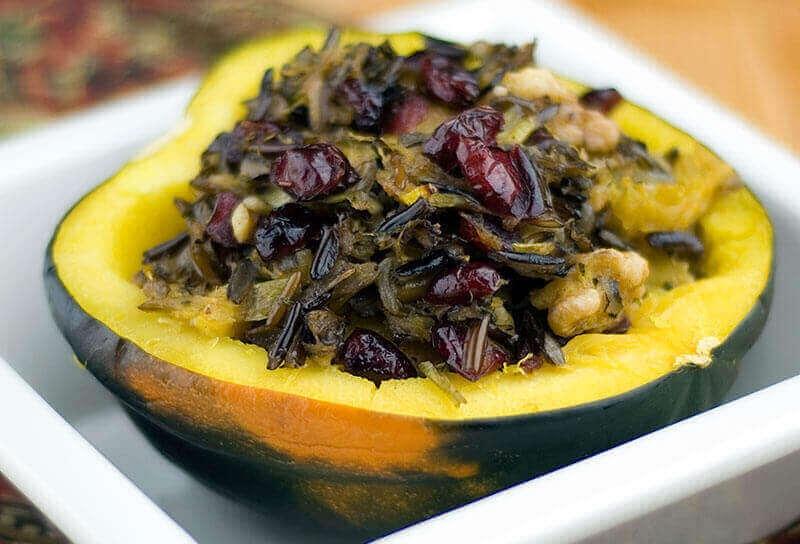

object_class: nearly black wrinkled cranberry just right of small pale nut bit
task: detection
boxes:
[255,203,318,261]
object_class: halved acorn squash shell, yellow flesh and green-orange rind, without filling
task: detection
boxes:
[45,30,773,535]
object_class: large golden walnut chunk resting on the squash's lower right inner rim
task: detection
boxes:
[531,249,650,337]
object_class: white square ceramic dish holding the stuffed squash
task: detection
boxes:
[0,1,800,544]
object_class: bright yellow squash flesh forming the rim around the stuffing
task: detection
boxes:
[48,30,772,419]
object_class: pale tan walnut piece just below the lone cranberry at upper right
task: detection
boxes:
[548,103,620,153]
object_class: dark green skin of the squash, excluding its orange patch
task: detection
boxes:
[44,231,774,538]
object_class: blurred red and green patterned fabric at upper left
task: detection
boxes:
[0,0,309,134]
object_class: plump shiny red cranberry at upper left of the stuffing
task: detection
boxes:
[271,143,353,200]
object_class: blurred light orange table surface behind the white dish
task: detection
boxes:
[306,0,800,152]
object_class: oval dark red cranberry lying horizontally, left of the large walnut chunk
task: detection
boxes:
[425,262,503,305]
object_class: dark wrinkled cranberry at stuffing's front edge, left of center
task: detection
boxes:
[338,329,417,383]
